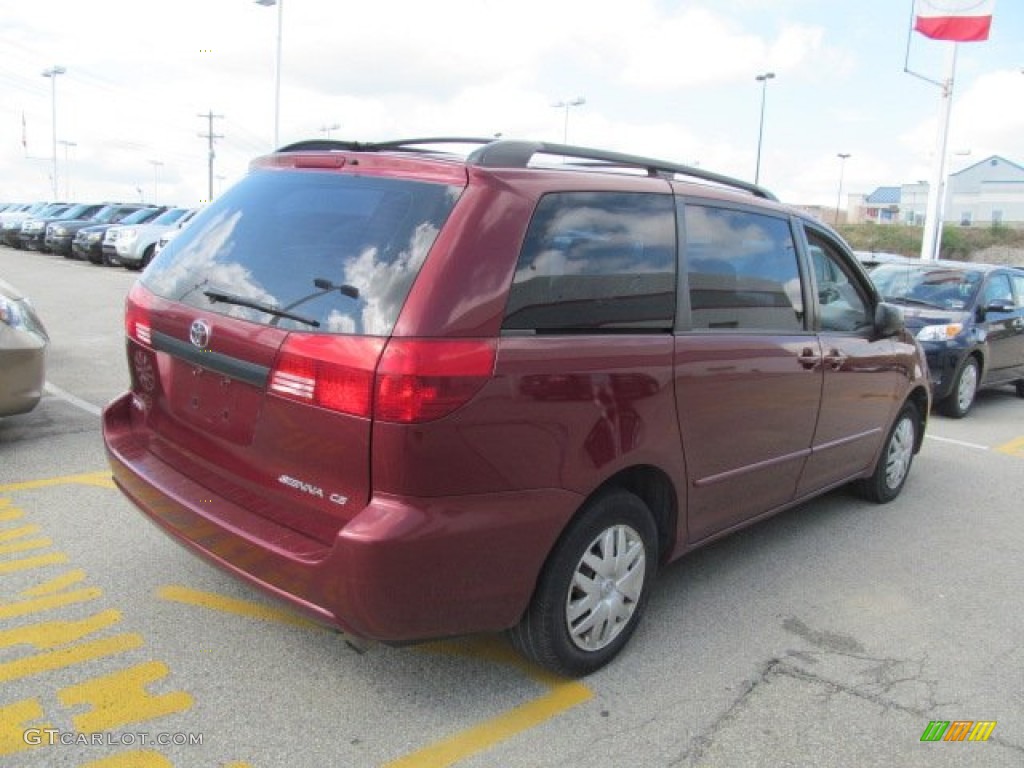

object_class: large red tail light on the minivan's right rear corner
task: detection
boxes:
[268,334,496,424]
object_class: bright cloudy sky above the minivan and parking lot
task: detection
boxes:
[0,0,1024,207]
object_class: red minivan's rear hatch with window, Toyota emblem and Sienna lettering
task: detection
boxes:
[126,159,465,552]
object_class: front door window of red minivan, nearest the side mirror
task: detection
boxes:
[806,229,872,333]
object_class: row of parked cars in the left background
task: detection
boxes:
[0,203,195,269]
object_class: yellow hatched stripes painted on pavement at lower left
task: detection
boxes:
[0,489,195,768]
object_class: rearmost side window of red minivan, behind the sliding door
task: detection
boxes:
[504,193,676,333]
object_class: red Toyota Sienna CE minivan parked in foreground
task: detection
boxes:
[103,139,930,676]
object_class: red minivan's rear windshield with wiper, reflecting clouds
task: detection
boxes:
[142,170,461,336]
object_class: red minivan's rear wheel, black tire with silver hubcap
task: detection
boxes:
[508,489,658,677]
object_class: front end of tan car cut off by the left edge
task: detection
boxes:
[0,280,49,417]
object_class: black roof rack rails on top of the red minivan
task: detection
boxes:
[278,136,778,201]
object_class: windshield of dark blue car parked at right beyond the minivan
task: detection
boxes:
[871,264,983,310]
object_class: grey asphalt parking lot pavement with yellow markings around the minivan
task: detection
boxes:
[0,248,1024,768]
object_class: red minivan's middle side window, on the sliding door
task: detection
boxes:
[685,205,804,331]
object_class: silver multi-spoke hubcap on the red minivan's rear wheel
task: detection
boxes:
[565,525,646,651]
